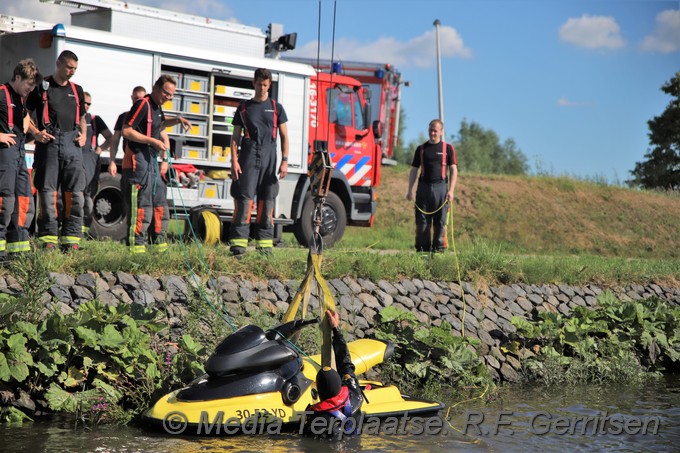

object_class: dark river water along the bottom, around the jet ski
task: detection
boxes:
[0,375,680,453]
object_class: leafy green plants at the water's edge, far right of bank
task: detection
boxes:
[508,292,680,385]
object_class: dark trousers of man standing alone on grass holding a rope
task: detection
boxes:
[415,181,449,252]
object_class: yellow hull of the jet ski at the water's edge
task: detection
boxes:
[143,330,443,434]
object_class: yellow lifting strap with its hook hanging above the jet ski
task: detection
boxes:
[283,141,335,367]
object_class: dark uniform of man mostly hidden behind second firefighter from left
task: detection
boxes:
[83,113,109,235]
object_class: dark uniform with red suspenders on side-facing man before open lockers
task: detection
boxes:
[123,95,170,253]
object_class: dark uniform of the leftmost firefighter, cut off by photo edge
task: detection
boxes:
[0,83,35,261]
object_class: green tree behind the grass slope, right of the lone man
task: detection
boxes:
[451,120,529,175]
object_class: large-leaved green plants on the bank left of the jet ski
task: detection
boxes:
[0,282,205,426]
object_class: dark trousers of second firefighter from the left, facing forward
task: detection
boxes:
[33,130,85,245]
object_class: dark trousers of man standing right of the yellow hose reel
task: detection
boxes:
[229,138,279,250]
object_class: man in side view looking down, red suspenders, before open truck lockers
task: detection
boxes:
[123,75,177,253]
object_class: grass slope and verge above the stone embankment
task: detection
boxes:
[0,166,680,285]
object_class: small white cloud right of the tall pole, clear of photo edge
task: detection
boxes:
[559,14,625,49]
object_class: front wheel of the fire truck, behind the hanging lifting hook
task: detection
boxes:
[294,192,347,247]
